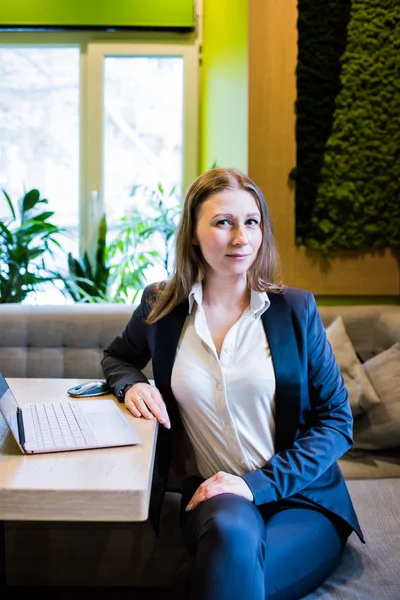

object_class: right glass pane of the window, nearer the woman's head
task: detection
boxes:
[103,55,183,220]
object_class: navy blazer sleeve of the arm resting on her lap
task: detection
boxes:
[243,294,353,505]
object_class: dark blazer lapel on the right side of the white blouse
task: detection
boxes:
[261,294,301,452]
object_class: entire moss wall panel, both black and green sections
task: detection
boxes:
[295,0,400,257]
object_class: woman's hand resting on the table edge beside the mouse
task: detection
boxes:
[124,382,171,429]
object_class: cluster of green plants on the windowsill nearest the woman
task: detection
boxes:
[64,184,180,303]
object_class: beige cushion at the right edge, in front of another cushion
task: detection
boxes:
[354,344,400,450]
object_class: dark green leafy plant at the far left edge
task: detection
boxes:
[0,189,64,303]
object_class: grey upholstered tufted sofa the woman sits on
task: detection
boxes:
[0,304,400,600]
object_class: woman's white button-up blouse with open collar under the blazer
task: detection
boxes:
[171,283,275,478]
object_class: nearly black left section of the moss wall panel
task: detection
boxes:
[295,0,350,245]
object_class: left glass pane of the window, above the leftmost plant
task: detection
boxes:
[0,46,80,240]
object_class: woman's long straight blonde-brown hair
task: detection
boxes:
[146,168,283,325]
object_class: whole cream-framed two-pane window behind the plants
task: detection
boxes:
[0,32,198,301]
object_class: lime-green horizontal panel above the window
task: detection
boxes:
[0,0,194,28]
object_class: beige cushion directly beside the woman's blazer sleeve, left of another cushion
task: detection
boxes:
[326,315,380,417]
